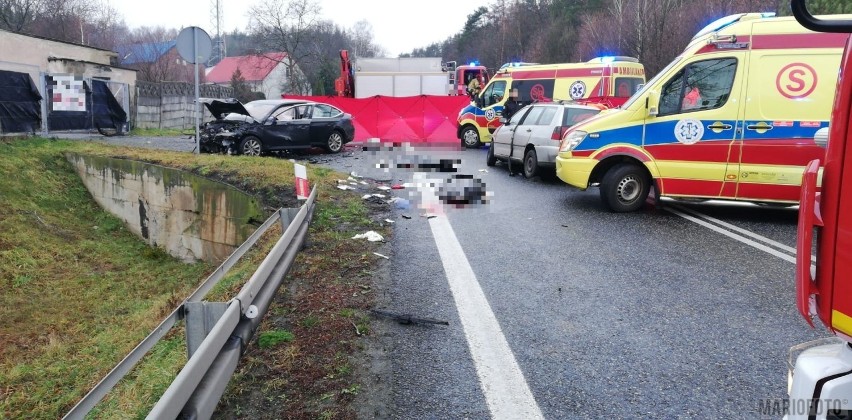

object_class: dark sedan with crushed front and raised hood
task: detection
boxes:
[200,98,355,156]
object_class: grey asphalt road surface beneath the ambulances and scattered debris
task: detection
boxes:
[58,136,828,419]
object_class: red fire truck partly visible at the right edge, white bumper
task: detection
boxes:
[787,0,852,420]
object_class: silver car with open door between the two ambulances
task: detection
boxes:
[486,102,601,178]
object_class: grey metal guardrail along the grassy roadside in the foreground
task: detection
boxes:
[64,187,317,419]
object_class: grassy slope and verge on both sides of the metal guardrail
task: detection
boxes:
[0,139,387,418]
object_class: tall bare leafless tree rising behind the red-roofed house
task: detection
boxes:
[249,0,321,94]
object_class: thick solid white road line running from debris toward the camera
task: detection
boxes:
[429,215,544,419]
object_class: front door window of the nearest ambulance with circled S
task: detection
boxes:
[660,58,737,115]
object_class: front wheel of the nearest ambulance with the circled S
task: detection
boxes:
[600,164,651,213]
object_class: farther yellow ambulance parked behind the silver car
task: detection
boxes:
[457,57,645,147]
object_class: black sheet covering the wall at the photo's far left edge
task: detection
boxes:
[0,70,41,133]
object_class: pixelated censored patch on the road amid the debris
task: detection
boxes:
[363,139,493,211]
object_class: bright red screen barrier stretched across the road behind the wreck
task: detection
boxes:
[282,95,470,143]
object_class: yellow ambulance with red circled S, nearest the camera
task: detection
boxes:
[556,13,845,212]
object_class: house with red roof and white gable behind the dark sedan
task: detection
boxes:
[207,52,310,99]
